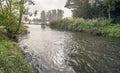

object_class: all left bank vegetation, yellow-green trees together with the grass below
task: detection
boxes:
[0,0,33,73]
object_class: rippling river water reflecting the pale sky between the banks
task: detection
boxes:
[20,25,120,73]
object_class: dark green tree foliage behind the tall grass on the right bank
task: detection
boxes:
[65,0,120,19]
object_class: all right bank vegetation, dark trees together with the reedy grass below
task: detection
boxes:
[50,0,120,38]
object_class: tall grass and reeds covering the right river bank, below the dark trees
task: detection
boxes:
[49,18,120,38]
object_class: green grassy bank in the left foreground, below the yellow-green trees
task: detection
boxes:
[0,26,34,73]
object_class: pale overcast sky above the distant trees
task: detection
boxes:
[30,0,72,17]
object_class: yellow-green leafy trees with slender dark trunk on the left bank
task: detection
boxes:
[0,0,33,38]
